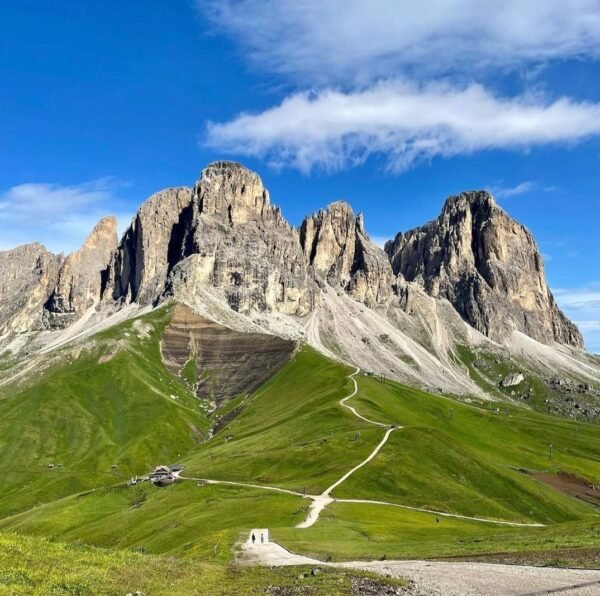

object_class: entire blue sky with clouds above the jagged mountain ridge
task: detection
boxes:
[0,0,600,352]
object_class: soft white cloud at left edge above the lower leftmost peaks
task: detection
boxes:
[0,178,129,252]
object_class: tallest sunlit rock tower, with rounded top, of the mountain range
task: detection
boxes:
[166,162,314,315]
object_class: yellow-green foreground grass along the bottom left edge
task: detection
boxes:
[0,534,403,596]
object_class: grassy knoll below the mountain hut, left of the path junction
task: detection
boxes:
[0,481,307,563]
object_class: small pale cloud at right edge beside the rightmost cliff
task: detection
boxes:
[554,282,600,354]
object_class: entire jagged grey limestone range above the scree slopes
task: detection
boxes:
[0,161,582,358]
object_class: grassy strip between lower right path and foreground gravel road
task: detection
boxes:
[271,503,600,568]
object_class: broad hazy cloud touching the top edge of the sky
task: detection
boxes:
[202,0,600,85]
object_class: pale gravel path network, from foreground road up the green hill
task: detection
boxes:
[176,368,600,596]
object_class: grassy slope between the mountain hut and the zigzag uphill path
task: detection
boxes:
[184,348,381,493]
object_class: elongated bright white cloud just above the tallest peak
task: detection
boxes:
[206,80,600,171]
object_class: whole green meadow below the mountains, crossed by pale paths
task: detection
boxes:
[0,309,600,569]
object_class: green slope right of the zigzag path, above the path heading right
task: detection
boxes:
[335,377,600,523]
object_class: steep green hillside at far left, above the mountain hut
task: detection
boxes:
[0,309,208,515]
